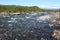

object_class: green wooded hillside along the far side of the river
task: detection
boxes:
[0,5,58,12]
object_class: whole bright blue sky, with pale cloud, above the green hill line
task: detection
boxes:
[0,0,60,9]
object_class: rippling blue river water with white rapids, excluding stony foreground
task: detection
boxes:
[0,13,59,40]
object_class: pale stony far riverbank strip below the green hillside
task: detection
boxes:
[0,12,47,16]
